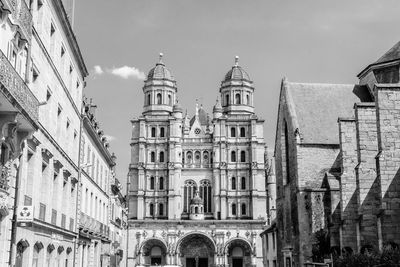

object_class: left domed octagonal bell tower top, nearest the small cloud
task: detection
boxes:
[143,53,178,115]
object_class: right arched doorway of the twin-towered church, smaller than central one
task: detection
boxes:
[225,239,252,267]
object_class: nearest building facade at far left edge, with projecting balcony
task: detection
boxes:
[0,0,39,267]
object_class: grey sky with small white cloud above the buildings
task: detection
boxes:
[74,0,400,186]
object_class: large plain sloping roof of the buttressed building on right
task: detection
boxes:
[284,82,372,144]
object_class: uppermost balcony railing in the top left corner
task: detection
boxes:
[0,0,32,40]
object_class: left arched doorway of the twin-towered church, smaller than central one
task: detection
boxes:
[140,238,167,266]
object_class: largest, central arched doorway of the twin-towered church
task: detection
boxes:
[178,233,215,267]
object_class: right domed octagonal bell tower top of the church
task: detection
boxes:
[219,56,254,114]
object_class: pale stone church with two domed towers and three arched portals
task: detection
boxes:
[127,54,267,267]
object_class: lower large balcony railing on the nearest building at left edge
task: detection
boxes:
[0,50,39,124]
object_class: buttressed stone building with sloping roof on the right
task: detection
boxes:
[275,40,400,267]
